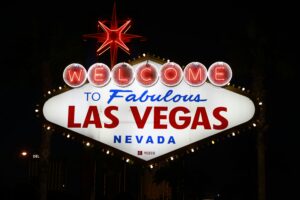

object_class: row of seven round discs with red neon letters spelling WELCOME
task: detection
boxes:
[63,62,232,87]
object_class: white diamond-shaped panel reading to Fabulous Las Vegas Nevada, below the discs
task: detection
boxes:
[43,65,255,161]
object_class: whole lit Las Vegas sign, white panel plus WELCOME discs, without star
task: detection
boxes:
[43,60,255,161]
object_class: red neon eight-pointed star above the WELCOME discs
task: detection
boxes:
[83,3,141,67]
